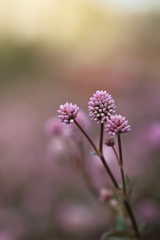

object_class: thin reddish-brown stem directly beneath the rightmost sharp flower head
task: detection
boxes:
[117,134,126,195]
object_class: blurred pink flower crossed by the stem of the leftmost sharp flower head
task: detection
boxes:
[66,110,90,141]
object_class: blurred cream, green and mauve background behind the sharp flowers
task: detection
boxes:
[0,0,160,240]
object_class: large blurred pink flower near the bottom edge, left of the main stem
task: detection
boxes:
[54,202,106,237]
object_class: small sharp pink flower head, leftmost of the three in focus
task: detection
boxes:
[57,102,79,124]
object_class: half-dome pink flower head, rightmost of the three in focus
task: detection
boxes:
[105,115,131,136]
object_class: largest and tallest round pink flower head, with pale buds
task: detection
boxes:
[88,91,116,124]
